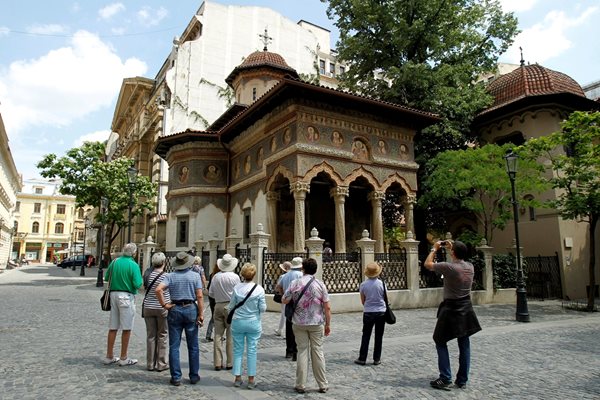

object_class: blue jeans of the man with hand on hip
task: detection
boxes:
[167,304,200,381]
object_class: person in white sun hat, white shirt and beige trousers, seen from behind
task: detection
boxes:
[208,254,241,371]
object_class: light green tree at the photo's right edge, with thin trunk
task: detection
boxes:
[525,111,600,311]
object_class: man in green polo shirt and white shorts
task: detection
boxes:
[103,243,143,366]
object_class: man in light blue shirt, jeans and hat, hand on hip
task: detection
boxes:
[156,251,204,386]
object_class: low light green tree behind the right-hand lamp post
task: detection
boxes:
[419,144,543,243]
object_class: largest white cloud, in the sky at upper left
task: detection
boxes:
[0,31,147,134]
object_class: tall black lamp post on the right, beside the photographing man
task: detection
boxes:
[504,149,529,322]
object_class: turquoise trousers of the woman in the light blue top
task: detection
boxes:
[231,318,262,376]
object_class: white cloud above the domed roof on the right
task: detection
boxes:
[502,7,599,64]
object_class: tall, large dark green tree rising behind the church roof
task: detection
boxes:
[322,0,518,162]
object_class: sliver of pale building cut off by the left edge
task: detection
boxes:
[0,115,21,269]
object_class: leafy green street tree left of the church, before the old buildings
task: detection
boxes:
[37,142,157,260]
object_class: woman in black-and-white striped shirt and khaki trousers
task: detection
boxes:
[142,252,171,372]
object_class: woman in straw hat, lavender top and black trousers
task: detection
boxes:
[354,262,385,365]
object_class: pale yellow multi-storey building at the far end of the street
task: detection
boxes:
[11,179,96,263]
